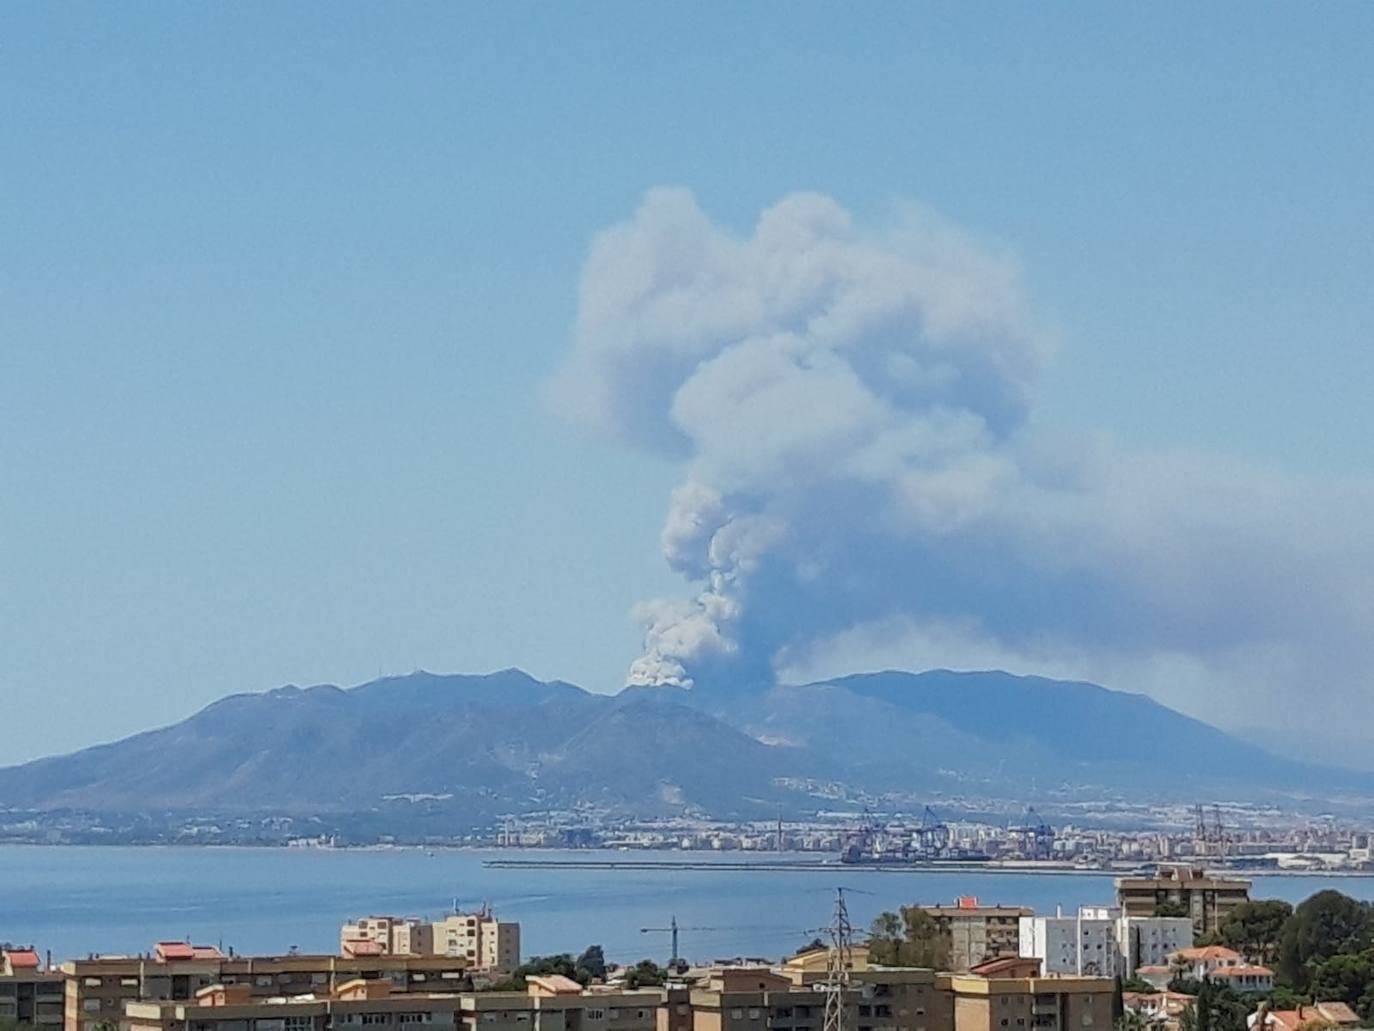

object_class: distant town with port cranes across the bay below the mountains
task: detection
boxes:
[13,801,1374,873]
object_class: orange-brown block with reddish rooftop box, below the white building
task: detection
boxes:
[937,957,1113,1031]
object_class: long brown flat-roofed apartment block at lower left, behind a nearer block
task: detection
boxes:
[62,942,469,1031]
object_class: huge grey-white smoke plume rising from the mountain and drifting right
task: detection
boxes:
[554,190,1374,723]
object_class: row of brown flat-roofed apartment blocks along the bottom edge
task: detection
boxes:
[2,943,1113,1031]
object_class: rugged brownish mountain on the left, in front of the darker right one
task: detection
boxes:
[0,669,790,812]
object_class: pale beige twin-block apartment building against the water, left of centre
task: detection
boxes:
[339,909,519,975]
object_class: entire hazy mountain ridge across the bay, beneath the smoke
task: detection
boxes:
[0,668,1374,822]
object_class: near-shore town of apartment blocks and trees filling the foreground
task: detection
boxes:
[0,863,1374,1031]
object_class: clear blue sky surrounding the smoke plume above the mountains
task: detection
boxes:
[0,3,1374,760]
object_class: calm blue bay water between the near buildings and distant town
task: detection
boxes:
[0,845,1374,961]
